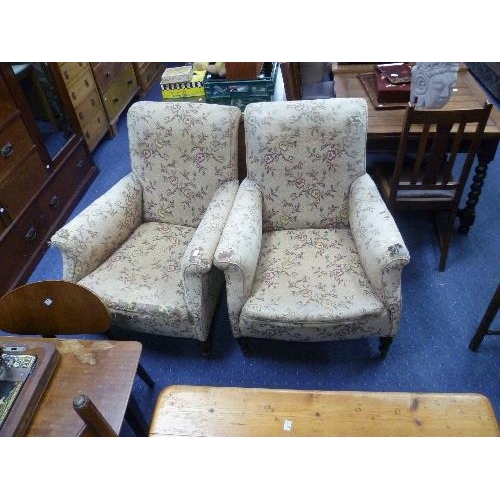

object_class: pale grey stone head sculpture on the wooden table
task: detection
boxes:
[410,62,459,109]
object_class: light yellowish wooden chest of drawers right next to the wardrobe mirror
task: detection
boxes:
[49,62,109,151]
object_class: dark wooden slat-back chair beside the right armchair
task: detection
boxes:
[373,102,492,271]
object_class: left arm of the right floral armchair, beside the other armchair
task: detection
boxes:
[214,179,262,336]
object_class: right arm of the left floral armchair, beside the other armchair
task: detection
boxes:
[181,180,238,276]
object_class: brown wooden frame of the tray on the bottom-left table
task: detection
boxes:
[0,337,60,436]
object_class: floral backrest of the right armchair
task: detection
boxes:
[245,98,367,231]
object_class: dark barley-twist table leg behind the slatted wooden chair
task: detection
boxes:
[457,138,498,234]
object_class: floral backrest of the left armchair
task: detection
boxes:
[128,101,241,227]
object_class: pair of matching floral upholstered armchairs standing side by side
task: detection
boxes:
[52,99,409,354]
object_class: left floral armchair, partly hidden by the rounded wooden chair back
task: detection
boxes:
[51,102,241,354]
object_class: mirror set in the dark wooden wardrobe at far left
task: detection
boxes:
[11,62,74,158]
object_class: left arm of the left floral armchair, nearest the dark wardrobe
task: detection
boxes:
[51,173,142,281]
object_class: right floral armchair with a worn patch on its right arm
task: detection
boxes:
[214,99,409,355]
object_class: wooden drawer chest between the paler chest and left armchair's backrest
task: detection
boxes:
[90,62,139,136]
